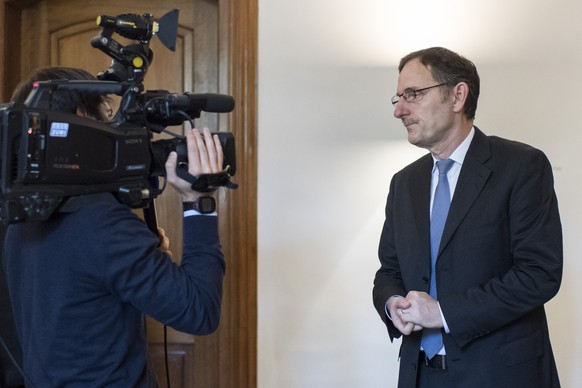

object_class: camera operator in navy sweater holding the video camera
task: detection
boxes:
[4,68,225,387]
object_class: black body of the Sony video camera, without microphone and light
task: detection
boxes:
[0,96,236,224]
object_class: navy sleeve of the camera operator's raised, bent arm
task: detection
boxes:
[97,203,225,335]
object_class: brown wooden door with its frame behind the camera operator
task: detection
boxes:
[0,0,256,388]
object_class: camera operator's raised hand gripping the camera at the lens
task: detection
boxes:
[166,128,224,202]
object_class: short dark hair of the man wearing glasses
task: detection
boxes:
[398,47,479,119]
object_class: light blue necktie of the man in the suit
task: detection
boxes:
[421,159,455,359]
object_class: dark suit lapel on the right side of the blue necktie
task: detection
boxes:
[439,127,491,255]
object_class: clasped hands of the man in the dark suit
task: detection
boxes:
[386,291,443,335]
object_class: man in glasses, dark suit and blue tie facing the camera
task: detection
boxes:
[373,48,563,388]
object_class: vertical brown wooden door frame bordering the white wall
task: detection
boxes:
[194,0,258,388]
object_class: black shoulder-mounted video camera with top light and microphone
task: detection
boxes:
[0,9,237,224]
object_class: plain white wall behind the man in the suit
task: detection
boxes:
[258,0,582,388]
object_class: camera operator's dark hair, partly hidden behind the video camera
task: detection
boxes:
[10,67,109,121]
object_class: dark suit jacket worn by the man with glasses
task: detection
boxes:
[373,129,563,388]
